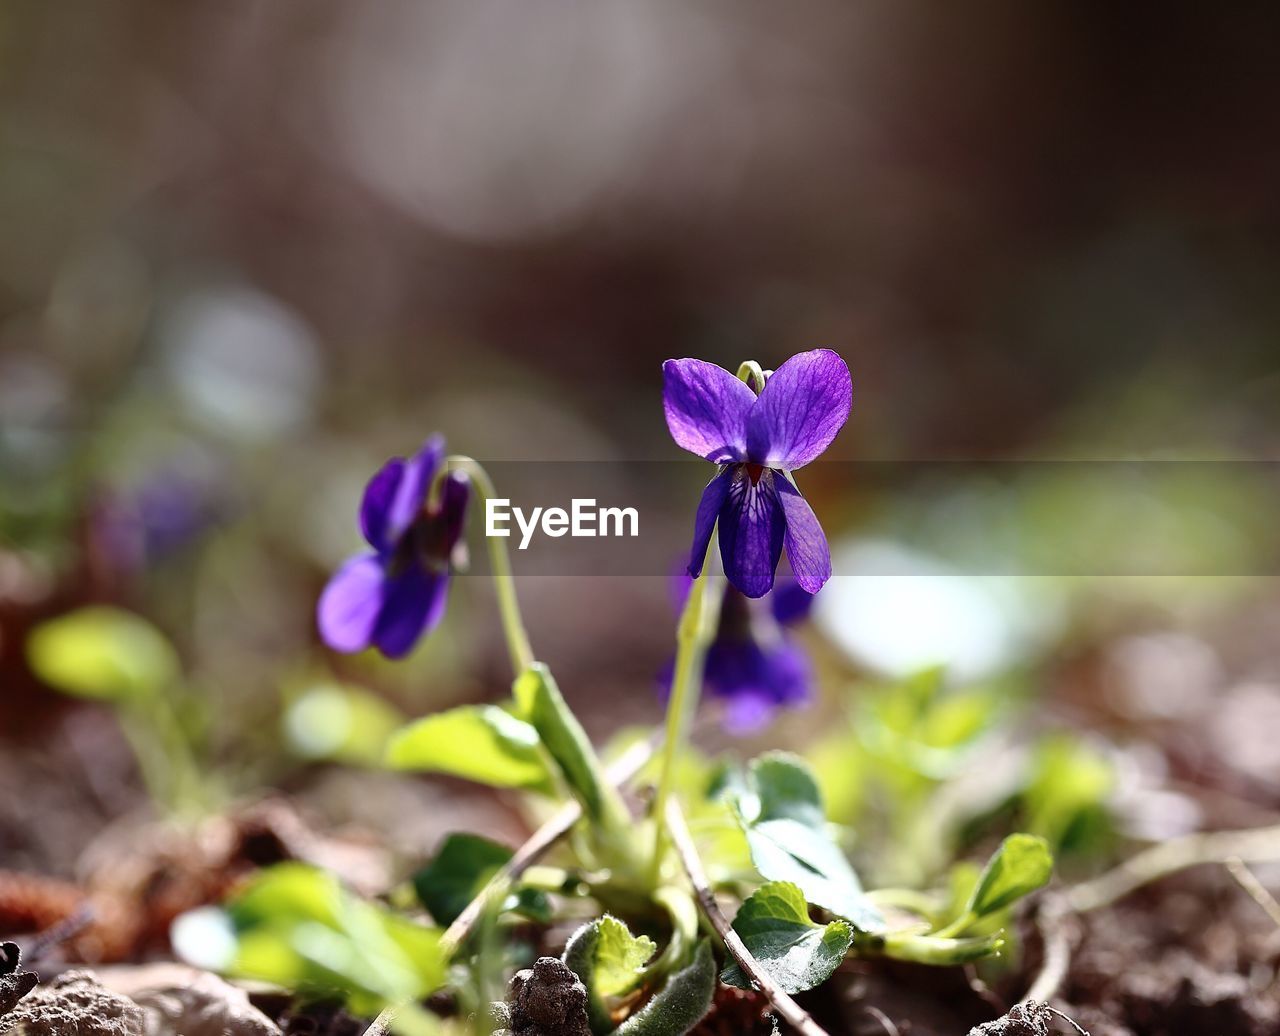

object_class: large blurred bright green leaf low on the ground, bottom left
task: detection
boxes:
[225,863,447,1014]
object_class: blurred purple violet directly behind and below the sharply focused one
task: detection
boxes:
[662,574,813,734]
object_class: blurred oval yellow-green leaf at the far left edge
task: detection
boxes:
[27,607,179,700]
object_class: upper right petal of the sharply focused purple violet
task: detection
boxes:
[746,348,854,471]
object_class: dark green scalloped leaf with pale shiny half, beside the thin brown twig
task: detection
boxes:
[721,881,854,992]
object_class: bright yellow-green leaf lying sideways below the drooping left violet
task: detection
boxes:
[387,706,552,793]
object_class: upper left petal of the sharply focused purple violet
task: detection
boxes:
[662,360,755,464]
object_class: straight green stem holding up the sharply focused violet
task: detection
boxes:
[649,534,724,887]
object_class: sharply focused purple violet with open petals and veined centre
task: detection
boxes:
[662,348,852,597]
